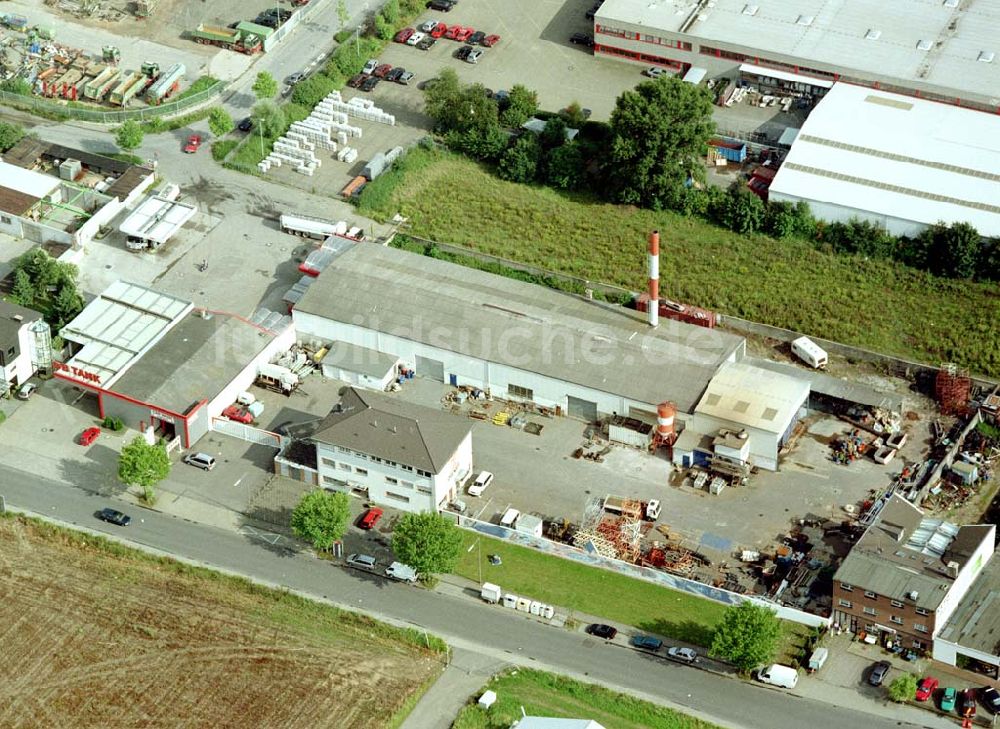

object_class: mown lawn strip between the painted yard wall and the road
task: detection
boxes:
[455,531,807,653]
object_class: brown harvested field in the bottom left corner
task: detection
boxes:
[0,519,441,727]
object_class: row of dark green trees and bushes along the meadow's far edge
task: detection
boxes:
[425,69,1000,281]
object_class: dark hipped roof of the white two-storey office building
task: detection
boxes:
[312,387,471,473]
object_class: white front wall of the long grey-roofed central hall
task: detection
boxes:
[293,311,696,414]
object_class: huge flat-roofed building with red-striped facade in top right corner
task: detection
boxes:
[594,0,1000,111]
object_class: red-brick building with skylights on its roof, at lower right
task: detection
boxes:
[833,495,996,651]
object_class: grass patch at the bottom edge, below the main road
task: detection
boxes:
[452,669,715,729]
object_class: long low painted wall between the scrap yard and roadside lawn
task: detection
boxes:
[458,516,831,628]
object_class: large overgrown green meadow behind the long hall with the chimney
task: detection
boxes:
[361,149,1000,376]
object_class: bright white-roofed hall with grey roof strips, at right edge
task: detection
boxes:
[772,82,1000,237]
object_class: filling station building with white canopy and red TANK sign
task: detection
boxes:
[54,281,295,448]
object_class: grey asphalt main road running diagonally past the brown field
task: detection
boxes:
[0,465,952,729]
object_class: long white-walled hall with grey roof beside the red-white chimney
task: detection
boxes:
[293,245,745,421]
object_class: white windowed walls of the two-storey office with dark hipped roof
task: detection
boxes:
[316,432,472,512]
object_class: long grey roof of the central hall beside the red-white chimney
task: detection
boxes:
[294,244,744,413]
